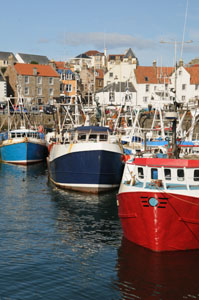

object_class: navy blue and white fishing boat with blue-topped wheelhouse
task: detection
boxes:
[47,126,124,193]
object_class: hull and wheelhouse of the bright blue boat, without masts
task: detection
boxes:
[0,127,48,165]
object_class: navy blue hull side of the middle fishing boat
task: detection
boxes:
[49,150,123,190]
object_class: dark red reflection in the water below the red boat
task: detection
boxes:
[116,238,199,300]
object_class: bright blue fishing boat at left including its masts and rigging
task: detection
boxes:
[0,97,48,165]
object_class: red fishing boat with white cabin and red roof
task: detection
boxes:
[118,158,199,251]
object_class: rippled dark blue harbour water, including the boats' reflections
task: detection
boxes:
[0,164,199,300]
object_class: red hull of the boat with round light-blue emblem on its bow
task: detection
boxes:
[118,191,199,251]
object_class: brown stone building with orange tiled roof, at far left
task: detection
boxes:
[4,63,60,104]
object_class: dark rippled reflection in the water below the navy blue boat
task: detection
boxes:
[49,188,121,247]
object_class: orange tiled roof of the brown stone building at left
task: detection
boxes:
[14,63,59,77]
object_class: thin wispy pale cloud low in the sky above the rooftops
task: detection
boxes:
[59,32,156,49]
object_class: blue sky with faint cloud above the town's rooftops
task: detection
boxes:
[0,0,199,66]
